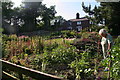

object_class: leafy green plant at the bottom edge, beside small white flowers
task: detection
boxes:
[69,53,91,80]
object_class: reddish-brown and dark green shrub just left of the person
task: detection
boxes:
[73,32,101,58]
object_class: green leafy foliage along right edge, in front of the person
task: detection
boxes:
[101,37,120,80]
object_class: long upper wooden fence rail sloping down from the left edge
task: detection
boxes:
[0,59,63,80]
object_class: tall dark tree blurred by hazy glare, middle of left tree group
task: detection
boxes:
[20,2,42,31]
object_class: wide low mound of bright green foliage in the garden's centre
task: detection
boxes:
[43,45,76,65]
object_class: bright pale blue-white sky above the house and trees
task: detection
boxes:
[11,0,100,20]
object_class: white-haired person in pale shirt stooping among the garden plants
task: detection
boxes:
[99,29,113,59]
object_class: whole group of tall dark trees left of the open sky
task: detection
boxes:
[2,2,56,32]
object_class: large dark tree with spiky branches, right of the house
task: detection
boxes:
[82,2,120,35]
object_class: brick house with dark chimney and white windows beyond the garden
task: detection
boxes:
[62,13,90,31]
